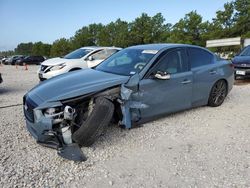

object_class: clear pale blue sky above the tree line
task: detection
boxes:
[0,0,229,51]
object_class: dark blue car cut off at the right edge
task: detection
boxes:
[232,45,250,79]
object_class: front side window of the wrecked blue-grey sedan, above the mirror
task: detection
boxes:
[157,49,188,74]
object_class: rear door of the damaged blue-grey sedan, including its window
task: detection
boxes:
[187,47,218,106]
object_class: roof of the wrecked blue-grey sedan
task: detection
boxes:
[128,43,205,51]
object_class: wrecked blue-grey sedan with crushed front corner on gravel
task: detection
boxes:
[23,44,234,160]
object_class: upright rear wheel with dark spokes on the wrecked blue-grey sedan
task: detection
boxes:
[208,80,227,107]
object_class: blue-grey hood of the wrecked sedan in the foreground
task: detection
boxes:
[26,69,129,105]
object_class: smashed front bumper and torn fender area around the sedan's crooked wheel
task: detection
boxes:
[24,77,147,161]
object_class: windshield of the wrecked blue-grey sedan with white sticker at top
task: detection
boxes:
[96,49,158,76]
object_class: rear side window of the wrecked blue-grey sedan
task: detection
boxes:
[188,48,213,68]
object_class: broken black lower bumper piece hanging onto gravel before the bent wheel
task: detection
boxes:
[37,132,87,162]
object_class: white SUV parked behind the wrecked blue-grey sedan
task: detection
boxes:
[38,47,121,81]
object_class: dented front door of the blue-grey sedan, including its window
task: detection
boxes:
[139,48,193,118]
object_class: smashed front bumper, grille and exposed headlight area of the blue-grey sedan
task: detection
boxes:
[24,98,86,161]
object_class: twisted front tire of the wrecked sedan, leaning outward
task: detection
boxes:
[72,97,114,146]
